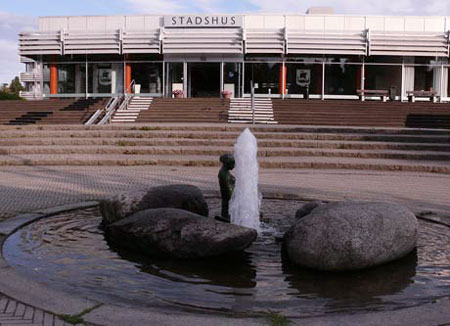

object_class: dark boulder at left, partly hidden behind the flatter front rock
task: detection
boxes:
[100,185,208,225]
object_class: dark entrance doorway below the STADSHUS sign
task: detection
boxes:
[188,63,220,97]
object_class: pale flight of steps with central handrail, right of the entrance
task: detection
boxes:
[228,98,277,124]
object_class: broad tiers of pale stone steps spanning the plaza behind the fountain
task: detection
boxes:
[0,123,450,173]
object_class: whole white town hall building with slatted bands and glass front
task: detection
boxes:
[19,10,450,101]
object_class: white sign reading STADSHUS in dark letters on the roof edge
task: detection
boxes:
[164,15,242,27]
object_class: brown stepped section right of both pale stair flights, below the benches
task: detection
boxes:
[273,99,450,128]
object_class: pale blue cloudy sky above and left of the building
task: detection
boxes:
[0,0,450,83]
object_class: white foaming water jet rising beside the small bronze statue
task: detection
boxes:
[230,128,262,233]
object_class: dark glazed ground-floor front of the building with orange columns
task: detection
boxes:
[35,55,450,100]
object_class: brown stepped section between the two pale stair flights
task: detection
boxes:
[136,98,230,123]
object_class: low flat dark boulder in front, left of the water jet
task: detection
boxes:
[107,208,257,259]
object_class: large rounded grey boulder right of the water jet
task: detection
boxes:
[284,202,418,271]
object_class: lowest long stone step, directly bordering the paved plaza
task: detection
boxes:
[0,154,450,173]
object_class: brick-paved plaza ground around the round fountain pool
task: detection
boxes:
[0,166,450,326]
